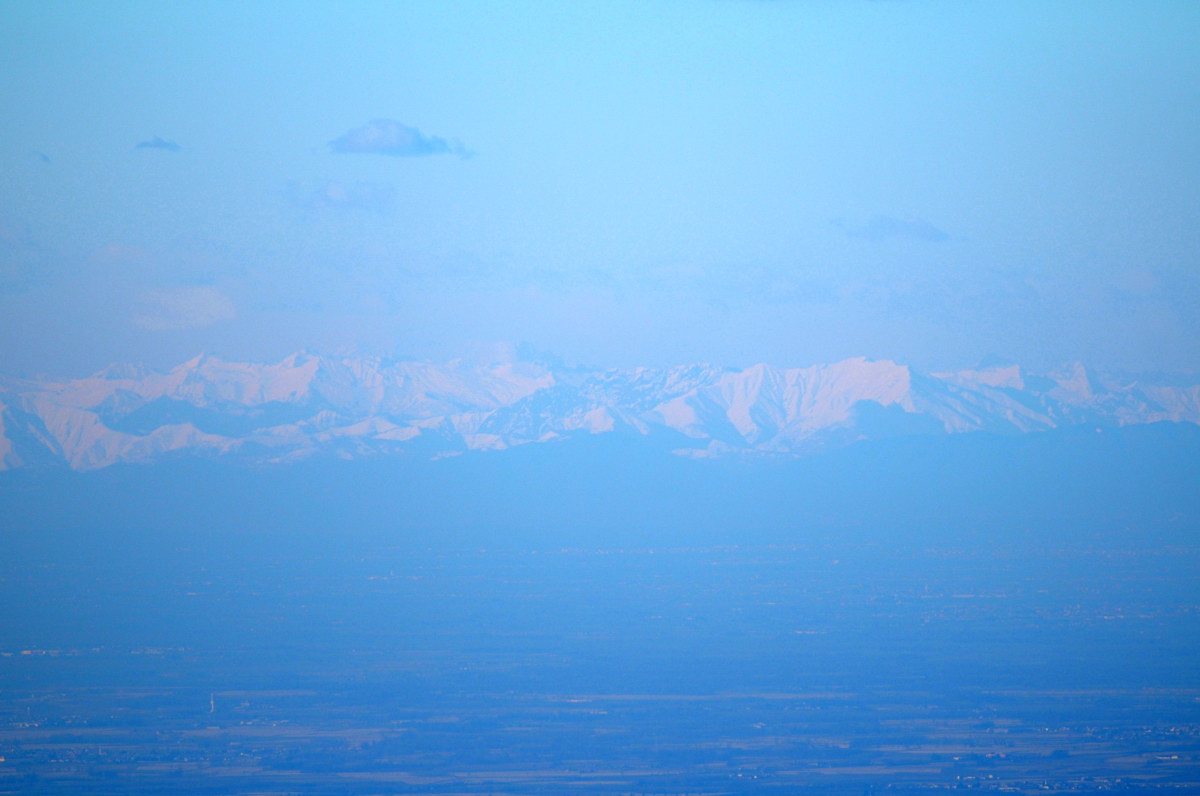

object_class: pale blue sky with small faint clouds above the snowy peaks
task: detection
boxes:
[0,0,1200,376]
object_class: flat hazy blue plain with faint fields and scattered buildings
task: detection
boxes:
[0,533,1200,795]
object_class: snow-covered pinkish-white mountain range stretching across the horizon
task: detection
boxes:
[0,352,1200,471]
